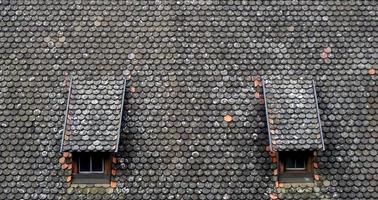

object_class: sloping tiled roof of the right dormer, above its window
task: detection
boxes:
[263,76,323,151]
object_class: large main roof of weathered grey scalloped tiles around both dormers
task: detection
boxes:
[0,0,378,200]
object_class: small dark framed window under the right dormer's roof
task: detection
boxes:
[278,151,314,183]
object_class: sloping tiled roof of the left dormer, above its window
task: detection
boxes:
[62,76,125,152]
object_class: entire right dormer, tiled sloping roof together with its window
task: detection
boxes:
[262,76,324,183]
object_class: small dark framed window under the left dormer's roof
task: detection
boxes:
[72,153,111,184]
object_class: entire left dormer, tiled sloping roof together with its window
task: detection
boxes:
[60,76,126,188]
